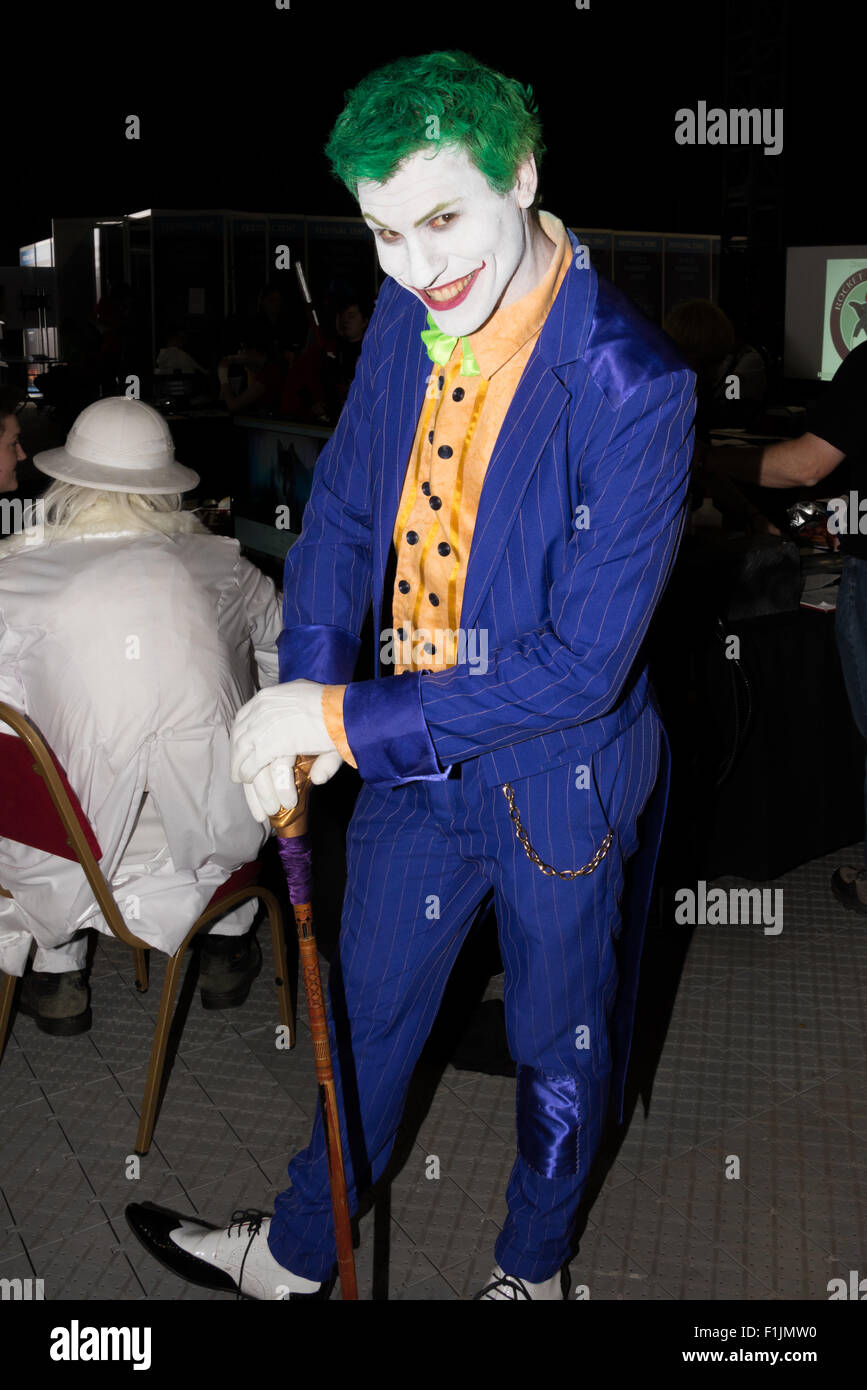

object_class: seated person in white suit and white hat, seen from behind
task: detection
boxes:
[0,398,281,1036]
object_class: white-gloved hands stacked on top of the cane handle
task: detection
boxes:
[231,681,343,821]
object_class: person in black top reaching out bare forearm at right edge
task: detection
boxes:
[707,343,867,913]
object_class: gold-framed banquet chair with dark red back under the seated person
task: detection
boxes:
[0,702,295,1154]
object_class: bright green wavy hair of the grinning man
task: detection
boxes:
[325,51,545,206]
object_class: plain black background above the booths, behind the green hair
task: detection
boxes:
[0,0,867,358]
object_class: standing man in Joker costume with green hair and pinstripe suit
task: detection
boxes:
[129,53,693,1300]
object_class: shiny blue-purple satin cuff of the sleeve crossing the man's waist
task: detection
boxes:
[345,671,452,787]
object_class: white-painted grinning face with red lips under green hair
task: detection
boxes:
[358,146,539,338]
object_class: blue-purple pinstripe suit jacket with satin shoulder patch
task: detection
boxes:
[278,232,695,787]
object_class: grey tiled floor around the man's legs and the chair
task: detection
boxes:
[0,851,867,1301]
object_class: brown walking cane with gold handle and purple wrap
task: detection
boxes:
[271,758,358,1298]
